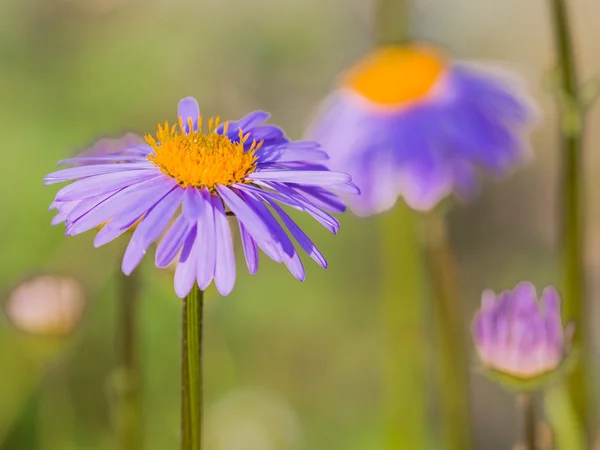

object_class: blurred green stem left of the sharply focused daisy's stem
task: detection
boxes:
[117,271,142,450]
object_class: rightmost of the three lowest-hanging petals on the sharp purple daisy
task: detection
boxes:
[211,195,235,295]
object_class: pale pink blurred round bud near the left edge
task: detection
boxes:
[5,275,85,337]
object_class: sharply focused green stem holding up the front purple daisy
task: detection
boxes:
[181,286,204,450]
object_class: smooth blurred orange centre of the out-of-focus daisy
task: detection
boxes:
[342,45,445,106]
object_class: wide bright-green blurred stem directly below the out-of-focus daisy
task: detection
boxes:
[381,202,430,450]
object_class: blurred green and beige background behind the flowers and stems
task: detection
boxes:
[0,0,600,450]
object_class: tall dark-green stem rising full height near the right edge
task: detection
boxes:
[550,0,592,442]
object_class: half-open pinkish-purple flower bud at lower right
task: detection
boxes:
[473,282,573,380]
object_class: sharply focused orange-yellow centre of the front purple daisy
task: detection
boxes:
[146,117,262,189]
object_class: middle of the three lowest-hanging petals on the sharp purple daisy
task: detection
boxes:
[196,188,217,289]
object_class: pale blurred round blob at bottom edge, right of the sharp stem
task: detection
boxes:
[206,389,301,450]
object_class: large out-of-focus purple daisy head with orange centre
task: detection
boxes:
[308,44,535,215]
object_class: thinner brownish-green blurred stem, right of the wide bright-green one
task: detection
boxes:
[424,211,471,450]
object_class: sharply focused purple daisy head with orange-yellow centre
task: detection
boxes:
[44,98,359,297]
